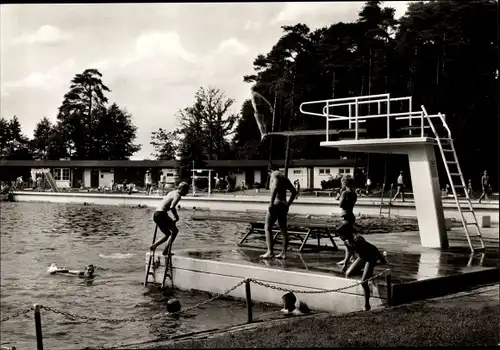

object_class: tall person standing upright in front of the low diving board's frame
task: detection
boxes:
[260,168,297,259]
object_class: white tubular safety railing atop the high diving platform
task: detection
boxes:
[300,94,446,141]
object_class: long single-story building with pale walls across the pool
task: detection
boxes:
[0,158,360,188]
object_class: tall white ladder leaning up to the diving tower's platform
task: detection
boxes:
[421,105,485,253]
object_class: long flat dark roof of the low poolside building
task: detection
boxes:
[0,159,361,168]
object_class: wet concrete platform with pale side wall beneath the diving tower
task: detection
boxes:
[146,229,499,313]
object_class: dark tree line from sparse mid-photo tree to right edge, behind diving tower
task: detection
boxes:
[152,0,498,186]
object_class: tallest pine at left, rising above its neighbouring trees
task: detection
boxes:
[57,69,111,159]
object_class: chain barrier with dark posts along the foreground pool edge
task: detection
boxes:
[0,269,392,350]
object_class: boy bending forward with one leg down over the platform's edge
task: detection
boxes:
[338,226,387,311]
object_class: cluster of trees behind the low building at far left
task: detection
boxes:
[0,69,141,160]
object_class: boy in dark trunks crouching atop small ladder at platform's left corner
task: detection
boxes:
[150,182,189,255]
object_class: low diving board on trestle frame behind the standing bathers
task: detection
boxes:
[191,214,338,252]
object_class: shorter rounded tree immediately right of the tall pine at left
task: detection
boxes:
[91,103,141,160]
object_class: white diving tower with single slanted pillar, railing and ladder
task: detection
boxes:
[292,94,484,252]
